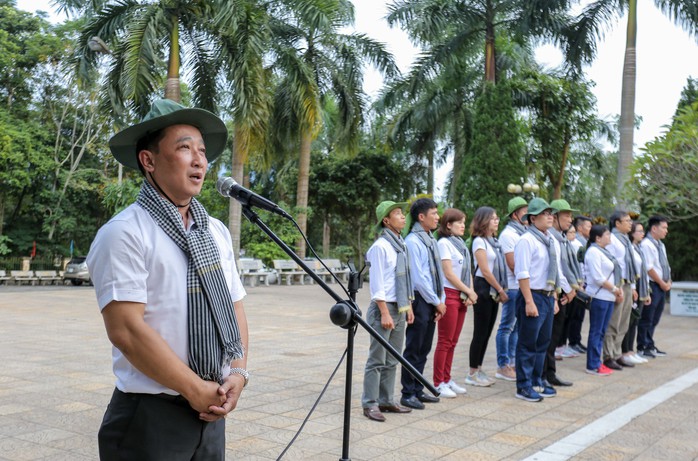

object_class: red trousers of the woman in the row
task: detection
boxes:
[434,288,468,386]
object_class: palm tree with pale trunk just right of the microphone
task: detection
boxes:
[270,0,398,257]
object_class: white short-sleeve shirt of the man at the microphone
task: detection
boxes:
[87,204,245,394]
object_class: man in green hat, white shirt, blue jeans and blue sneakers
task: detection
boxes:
[514,197,564,402]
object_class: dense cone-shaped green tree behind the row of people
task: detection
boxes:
[454,82,526,216]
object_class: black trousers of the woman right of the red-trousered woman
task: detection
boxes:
[470,277,499,368]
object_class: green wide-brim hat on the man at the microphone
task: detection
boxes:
[109,99,228,170]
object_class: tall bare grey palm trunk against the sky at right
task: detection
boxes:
[616,0,637,208]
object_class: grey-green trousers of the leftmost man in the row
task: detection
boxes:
[361,301,407,408]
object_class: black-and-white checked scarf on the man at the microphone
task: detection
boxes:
[137,180,245,383]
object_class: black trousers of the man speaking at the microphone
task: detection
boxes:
[98,389,225,461]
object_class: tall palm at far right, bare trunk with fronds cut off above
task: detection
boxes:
[567,0,698,202]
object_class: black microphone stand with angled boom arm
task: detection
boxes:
[242,204,439,461]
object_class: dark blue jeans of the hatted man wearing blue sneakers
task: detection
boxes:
[516,292,555,389]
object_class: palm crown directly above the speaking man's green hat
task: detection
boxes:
[63,0,227,116]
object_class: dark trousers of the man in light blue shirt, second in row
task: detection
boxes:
[400,291,436,398]
